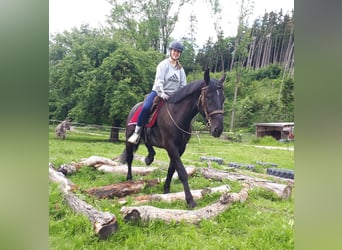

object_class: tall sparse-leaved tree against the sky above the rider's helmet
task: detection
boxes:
[108,0,192,54]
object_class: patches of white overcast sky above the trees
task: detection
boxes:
[49,0,294,47]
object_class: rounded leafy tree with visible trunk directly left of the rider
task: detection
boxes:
[99,46,163,141]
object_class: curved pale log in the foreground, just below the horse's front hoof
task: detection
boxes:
[120,185,249,224]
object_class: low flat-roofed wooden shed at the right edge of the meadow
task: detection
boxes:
[255,122,294,140]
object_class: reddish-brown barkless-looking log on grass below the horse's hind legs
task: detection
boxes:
[85,179,160,199]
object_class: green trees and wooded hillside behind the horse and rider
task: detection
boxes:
[49,0,294,141]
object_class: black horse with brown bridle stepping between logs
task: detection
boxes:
[124,70,226,208]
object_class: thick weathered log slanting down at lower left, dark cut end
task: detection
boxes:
[49,163,118,240]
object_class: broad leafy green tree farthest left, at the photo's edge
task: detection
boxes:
[49,25,117,123]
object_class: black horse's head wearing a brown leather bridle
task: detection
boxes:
[199,69,226,137]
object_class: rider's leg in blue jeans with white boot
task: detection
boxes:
[128,91,157,144]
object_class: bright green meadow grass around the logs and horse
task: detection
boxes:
[49,128,294,250]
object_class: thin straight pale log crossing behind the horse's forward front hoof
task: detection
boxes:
[119,185,230,205]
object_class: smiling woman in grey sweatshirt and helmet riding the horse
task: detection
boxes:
[128,41,186,144]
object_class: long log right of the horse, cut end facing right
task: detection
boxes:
[200,168,292,199]
